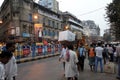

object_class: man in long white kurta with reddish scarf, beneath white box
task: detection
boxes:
[65,44,78,80]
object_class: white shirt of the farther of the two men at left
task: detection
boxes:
[5,56,17,80]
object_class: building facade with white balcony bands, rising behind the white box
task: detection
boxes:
[62,12,83,39]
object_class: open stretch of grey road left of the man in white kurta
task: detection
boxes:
[17,57,63,80]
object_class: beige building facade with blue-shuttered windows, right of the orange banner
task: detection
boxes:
[34,4,63,41]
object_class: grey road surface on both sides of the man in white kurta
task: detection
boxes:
[16,56,116,80]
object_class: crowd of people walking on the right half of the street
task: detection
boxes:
[59,43,120,80]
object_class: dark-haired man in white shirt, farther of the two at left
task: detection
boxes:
[4,42,17,80]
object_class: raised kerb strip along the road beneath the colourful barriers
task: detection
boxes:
[17,53,59,64]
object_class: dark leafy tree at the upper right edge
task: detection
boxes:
[106,0,120,40]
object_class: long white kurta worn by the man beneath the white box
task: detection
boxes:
[65,50,78,78]
